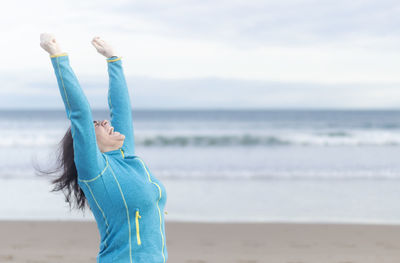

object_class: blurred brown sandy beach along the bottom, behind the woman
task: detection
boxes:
[0,221,400,263]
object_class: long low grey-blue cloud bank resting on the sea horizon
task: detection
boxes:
[4,76,400,109]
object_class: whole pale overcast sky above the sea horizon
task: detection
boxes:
[0,0,400,109]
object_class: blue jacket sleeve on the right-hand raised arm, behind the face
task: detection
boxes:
[107,56,135,157]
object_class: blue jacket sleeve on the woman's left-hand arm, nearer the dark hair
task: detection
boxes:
[50,53,106,180]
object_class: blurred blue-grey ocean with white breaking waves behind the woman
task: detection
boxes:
[0,110,400,223]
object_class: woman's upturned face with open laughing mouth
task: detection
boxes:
[93,120,125,152]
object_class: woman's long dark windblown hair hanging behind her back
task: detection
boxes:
[35,127,87,211]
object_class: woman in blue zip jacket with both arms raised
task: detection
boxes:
[40,33,168,263]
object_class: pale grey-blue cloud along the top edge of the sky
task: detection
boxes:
[79,0,400,47]
